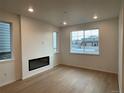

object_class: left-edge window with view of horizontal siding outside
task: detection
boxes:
[0,22,12,60]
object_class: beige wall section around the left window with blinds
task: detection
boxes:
[0,10,21,86]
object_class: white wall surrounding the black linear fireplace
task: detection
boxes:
[21,16,59,79]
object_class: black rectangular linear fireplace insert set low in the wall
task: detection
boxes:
[29,56,49,71]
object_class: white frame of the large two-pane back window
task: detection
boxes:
[70,28,100,56]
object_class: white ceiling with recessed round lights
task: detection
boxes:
[0,0,120,26]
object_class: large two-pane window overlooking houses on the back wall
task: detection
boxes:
[70,29,99,55]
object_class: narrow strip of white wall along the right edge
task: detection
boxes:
[118,2,124,93]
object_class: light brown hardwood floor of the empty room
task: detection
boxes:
[0,65,118,93]
